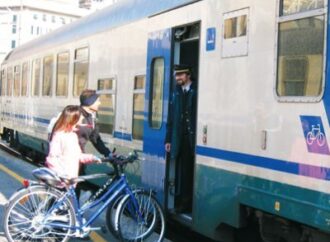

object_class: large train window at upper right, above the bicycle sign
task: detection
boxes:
[276,0,326,98]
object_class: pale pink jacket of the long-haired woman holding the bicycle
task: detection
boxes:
[46,131,95,178]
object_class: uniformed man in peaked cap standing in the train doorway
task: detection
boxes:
[165,65,197,212]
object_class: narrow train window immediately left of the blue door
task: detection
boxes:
[132,75,146,140]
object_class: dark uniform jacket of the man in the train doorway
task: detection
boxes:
[165,82,197,159]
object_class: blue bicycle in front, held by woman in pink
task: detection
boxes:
[4,153,165,242]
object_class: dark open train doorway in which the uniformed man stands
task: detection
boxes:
[166,23,200,222]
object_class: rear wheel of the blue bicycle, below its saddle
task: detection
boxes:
[3,186,76,242]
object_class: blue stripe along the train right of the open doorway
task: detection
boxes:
[196,146,330,181]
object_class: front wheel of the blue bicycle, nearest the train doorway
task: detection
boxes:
[115,191,165,242]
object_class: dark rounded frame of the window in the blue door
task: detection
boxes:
[148,56,165,130]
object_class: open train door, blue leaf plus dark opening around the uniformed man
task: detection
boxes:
[141,22,200,222]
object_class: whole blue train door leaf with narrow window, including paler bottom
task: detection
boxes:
[141,29,172,203]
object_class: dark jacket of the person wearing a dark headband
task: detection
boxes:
[77,108,110,156]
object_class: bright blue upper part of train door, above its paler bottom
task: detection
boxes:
[143,29,171,158]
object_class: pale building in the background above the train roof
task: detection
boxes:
[0,0,91,63]
